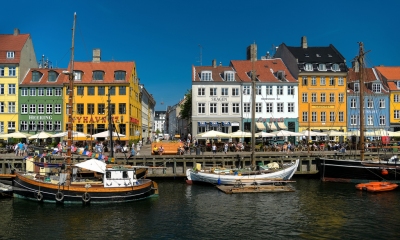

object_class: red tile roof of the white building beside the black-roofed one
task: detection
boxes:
[231,58,297,83]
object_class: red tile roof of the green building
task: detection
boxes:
[20,68,66,86]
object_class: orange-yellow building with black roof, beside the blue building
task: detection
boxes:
[275,37,348,136]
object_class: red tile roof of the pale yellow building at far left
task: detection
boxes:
[0,34,30,63]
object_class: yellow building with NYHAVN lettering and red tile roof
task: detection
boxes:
[64,49,142,144]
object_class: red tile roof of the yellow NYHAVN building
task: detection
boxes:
[64,62,135,84]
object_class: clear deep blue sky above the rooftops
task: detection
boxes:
[0,0,400,110]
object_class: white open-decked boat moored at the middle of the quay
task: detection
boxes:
[186,159,300,185]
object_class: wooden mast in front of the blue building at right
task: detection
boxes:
[358,42,365,161]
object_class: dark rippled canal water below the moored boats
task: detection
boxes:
[0,178,400,239]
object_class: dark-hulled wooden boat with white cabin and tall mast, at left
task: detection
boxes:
[13,14,158,203]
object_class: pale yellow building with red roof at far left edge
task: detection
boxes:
[0,29,38,134]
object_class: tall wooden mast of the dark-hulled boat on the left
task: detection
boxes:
[66,13,76,183]
